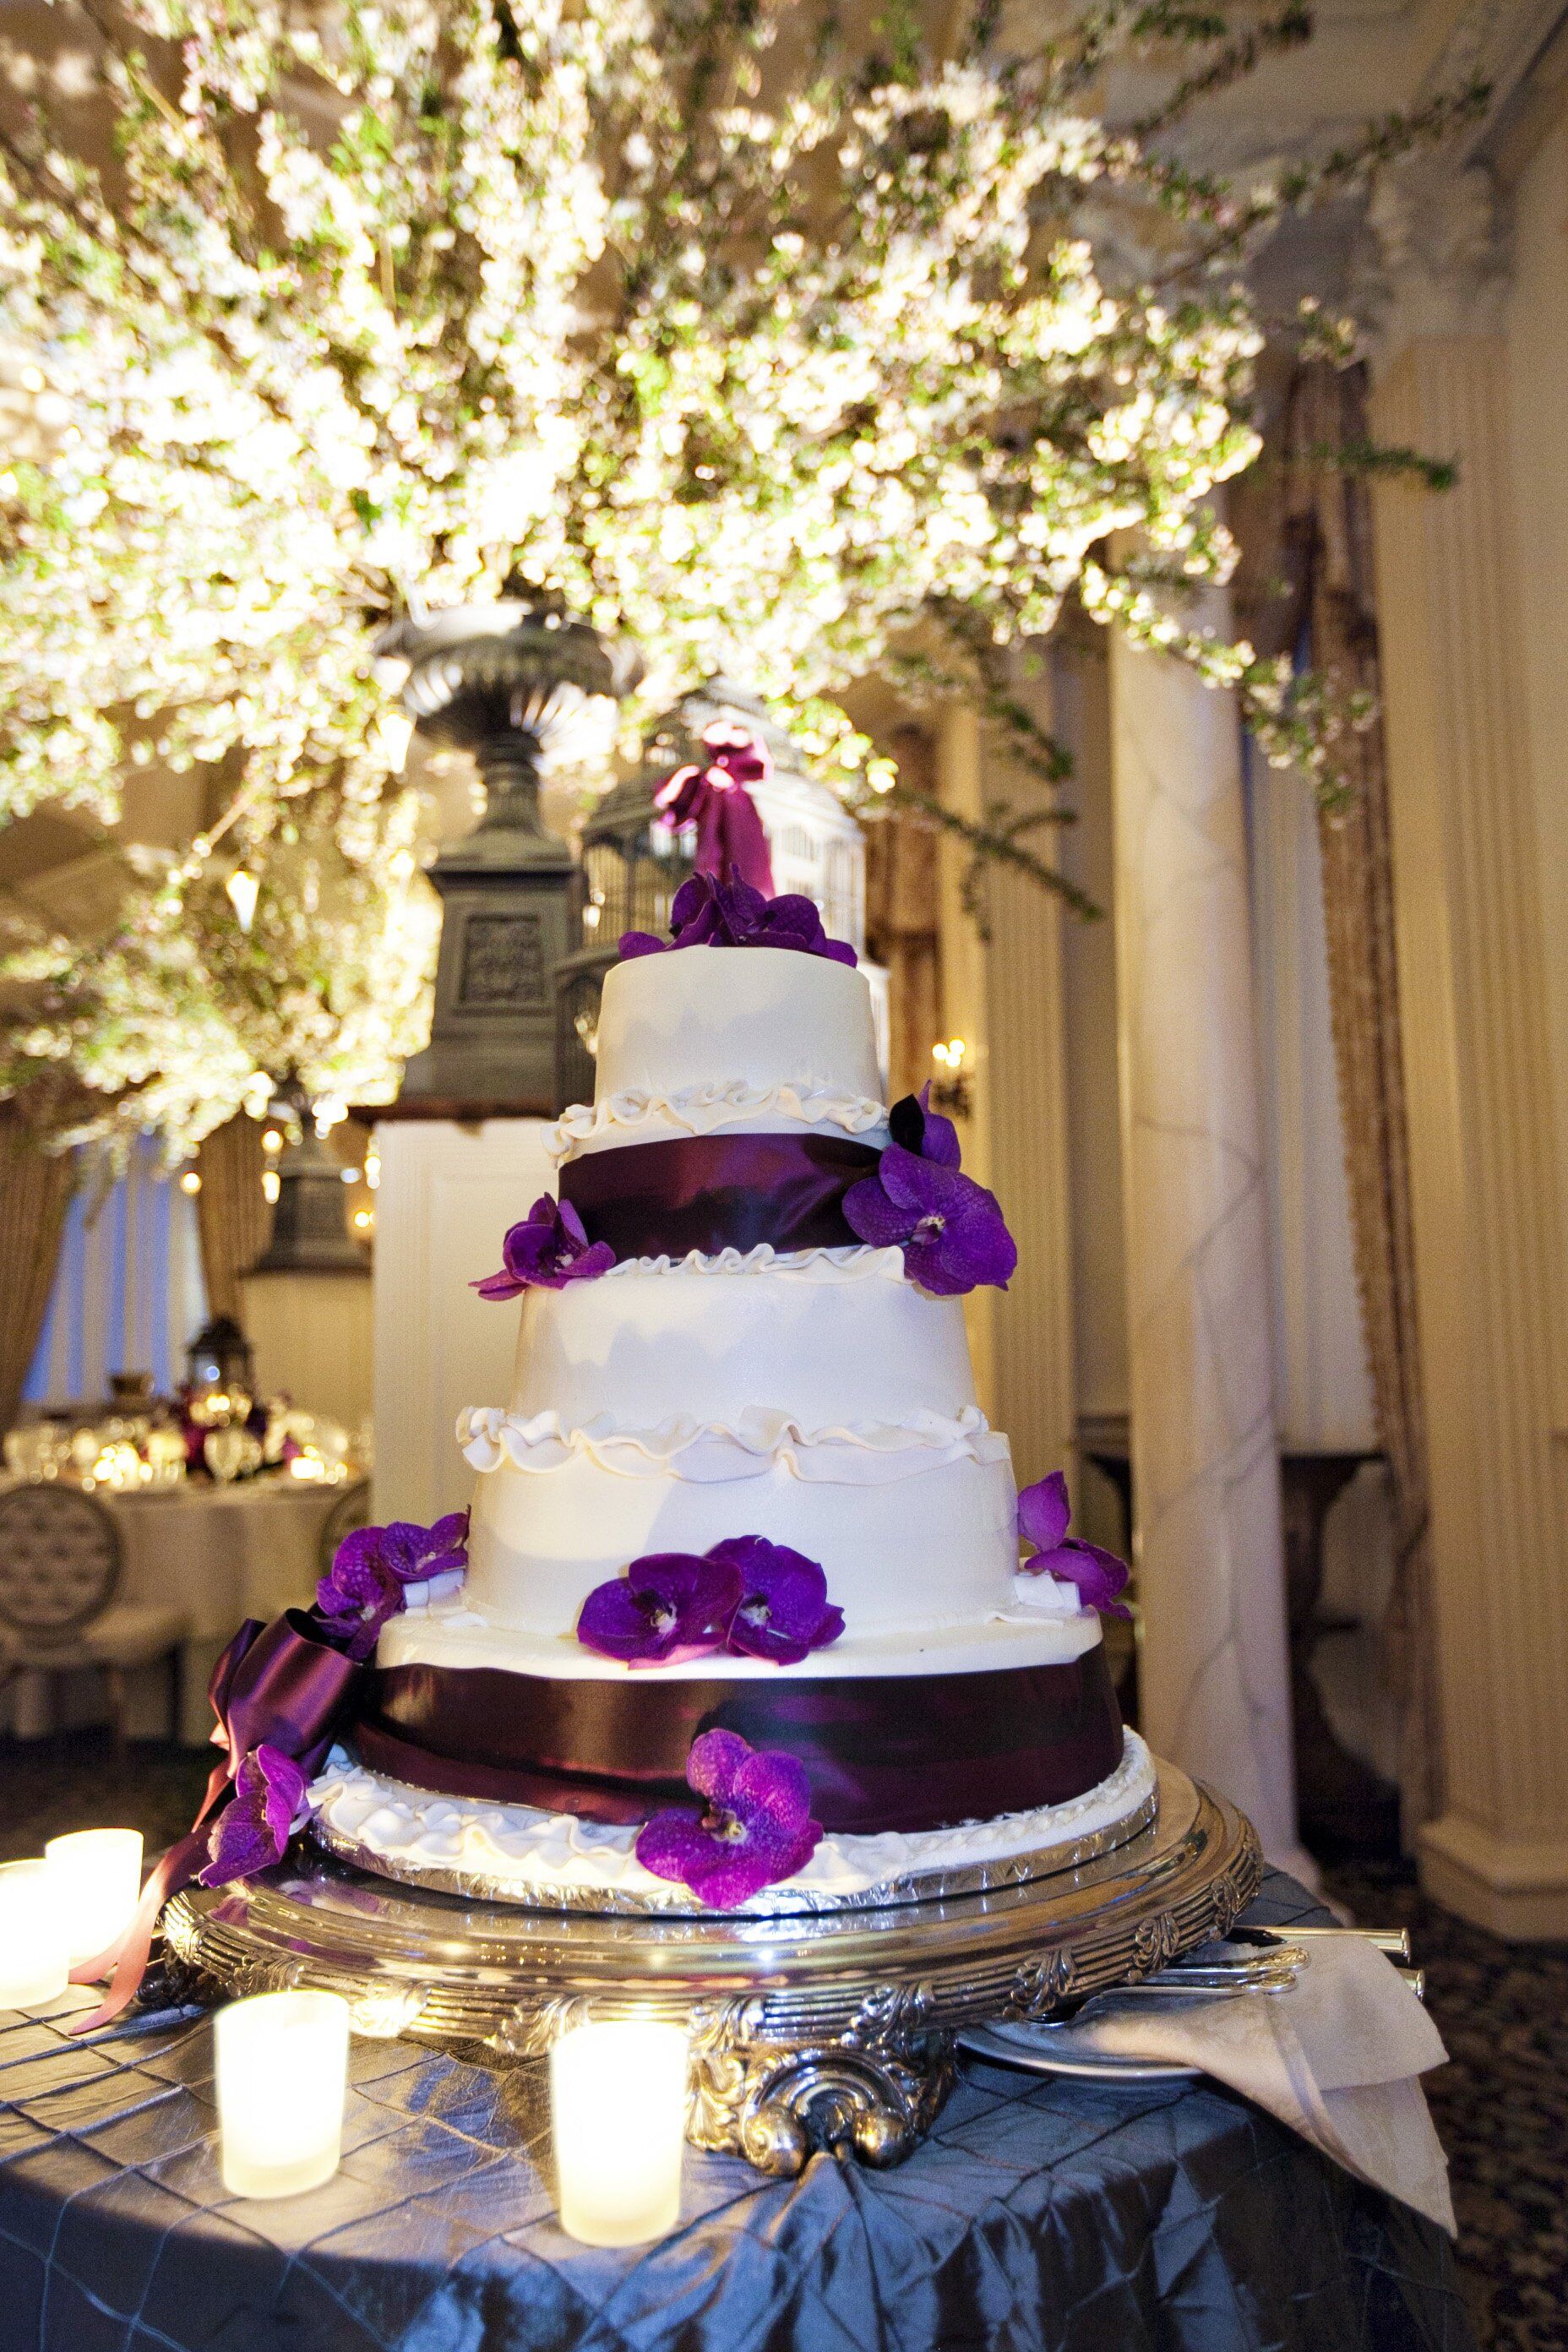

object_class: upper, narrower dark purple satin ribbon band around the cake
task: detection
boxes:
[562,1134,879,1258]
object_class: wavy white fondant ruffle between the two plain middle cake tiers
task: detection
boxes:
[459,1404,1009,1486]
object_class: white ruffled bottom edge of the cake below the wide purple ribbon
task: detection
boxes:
[310,1731,1157,1917]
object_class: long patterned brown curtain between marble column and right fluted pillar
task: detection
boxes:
[1283,367,1441,1837]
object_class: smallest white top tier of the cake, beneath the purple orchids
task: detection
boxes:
[595,948,881,1141]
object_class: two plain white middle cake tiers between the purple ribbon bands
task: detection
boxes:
[446,1251,1018,1635]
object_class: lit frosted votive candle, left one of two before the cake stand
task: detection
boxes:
[211,1992,348,2197]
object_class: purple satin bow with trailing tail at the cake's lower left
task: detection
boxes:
[68,1609,364,2034]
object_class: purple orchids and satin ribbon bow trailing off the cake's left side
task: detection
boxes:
[70,1510,468,2032]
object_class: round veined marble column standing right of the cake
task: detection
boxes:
[1109,595,1312,1872]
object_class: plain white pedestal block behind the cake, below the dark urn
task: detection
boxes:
[373,1115,555,1527]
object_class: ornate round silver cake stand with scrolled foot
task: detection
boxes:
[162,1764,1262,2173]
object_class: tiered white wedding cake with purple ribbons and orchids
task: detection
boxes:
[310,877,1154,1910]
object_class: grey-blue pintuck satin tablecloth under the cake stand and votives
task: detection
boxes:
[0,1875,1474,2352]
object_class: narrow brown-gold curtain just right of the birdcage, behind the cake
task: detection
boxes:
[865,727,943,1101]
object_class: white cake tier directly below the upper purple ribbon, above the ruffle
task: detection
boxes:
[509,1251,976,1429]
